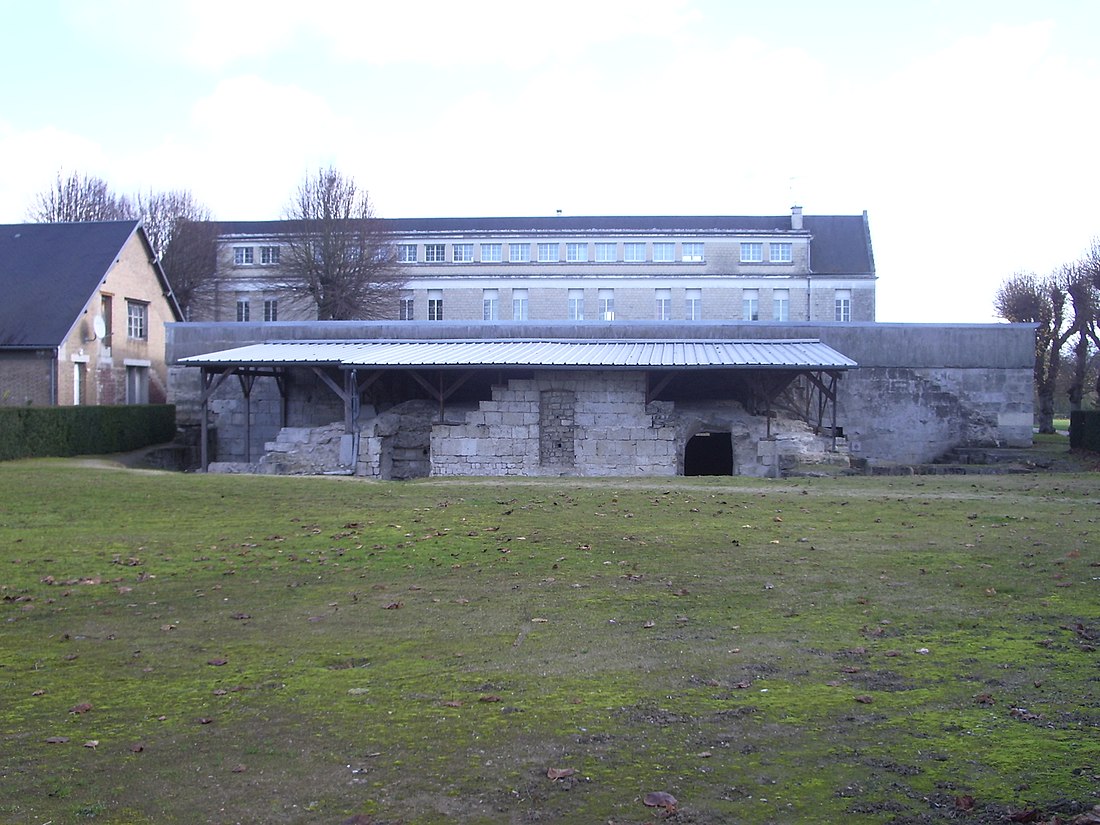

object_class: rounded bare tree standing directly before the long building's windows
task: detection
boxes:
[279,167,403,320]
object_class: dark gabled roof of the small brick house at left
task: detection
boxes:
[0,221,180,349]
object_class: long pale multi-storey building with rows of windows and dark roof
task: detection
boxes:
[200,207,876,323]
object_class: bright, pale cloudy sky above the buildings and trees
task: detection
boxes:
[0,0,1100,323]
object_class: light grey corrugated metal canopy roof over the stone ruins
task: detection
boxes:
[180,340,858,370]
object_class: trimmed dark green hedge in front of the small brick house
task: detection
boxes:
[0,404,176,461]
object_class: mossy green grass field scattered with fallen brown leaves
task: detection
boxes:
[0,455,1100,825]
